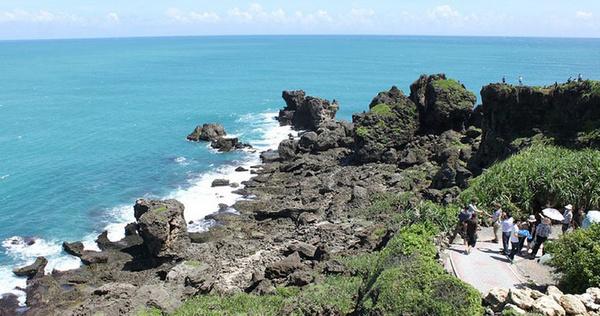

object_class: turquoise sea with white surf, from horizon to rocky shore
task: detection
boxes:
[0,36,600,298]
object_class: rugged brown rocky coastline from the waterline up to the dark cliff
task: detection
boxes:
[0,74,600,315]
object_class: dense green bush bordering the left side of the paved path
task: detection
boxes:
[351,224,482,315]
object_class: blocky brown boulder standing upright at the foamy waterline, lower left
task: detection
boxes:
[134,200,190,257]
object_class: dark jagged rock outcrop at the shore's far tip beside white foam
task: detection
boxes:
[278,90,339,131]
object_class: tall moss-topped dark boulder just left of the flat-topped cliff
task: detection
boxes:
[410,74,477,134]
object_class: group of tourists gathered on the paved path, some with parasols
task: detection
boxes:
[450,201,585,262]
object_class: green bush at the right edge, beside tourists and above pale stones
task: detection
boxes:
[546,224,600,293]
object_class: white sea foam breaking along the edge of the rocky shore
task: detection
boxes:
[0,112,293,304]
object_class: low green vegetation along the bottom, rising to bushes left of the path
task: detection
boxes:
[175,198,483,316]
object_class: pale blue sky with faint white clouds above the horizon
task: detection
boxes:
[0,0,600,40]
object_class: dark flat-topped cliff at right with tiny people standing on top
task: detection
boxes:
[477,81,600,166]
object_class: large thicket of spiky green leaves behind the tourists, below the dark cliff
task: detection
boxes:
[461,145,600,217]
